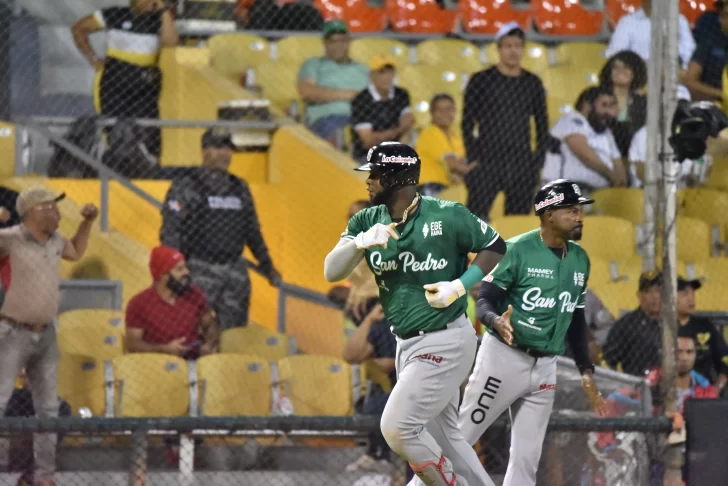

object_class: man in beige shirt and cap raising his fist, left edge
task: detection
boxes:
[0,187,98,486]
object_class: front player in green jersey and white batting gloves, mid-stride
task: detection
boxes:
[324,142,506,486]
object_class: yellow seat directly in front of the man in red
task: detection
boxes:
[112,353,190,417]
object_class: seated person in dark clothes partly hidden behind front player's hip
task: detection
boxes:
[344,303,411,486]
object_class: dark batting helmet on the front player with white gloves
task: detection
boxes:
[355,142,421,189]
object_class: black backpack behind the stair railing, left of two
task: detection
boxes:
[48,115,101,179]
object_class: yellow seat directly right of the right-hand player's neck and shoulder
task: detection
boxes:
[579,216,637,261]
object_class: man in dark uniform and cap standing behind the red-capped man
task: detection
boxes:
[160,128,280,330]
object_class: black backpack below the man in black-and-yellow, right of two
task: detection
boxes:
[103,118,157,179]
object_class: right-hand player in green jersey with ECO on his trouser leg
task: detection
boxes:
[410,179,604,486]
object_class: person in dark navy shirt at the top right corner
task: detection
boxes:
[684,0,728,101]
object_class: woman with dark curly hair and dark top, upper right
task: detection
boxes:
[599,51,647,160]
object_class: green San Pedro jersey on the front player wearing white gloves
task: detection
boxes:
[341,197,499,335]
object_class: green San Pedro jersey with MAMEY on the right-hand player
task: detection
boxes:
[484,230,590,354]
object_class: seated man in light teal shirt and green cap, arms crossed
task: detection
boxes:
[297,19,368,144]
